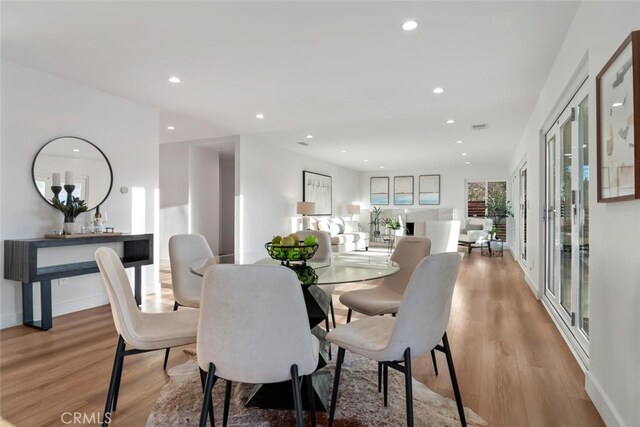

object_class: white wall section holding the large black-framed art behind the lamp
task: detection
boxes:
[235,135,360,253]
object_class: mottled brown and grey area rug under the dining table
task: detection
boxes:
[147,352,487,427]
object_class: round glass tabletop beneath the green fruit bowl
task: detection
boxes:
[190,252,400,285]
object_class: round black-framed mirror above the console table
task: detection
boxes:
[31,136,113,210]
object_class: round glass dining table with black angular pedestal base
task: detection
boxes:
[190,251,400,410]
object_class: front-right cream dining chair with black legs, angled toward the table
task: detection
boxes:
[327,252,466,426]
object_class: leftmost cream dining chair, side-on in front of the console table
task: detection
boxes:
[95,247,198,426]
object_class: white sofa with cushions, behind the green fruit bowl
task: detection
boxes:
[309,216,369,253]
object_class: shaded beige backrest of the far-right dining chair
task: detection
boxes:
[380,236,431,294]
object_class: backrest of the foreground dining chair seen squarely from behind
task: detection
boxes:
[197,264,318,383]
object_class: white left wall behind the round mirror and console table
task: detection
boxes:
[0,61,158,328]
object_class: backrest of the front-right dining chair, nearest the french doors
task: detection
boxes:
[389,252,463,357]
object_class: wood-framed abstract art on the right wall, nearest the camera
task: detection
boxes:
[596,31,640,203]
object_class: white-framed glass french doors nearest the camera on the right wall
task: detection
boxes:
[545,85,590,357]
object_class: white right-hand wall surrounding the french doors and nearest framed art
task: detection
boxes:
[510,2,640,426]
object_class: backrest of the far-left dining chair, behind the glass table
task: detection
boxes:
[169,234,213,308]
